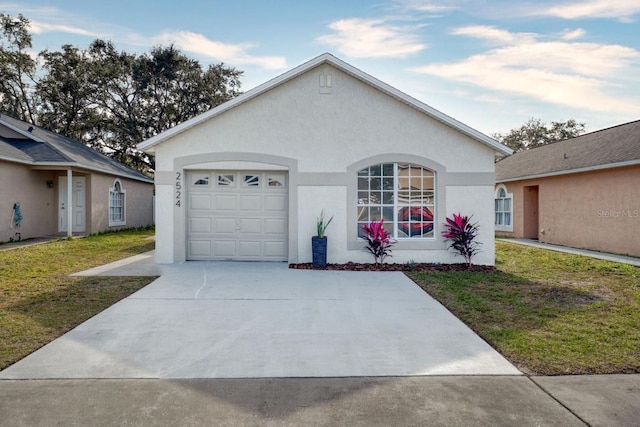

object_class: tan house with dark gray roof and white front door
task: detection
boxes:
[0,114,154,242]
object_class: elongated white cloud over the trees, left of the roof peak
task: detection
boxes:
[154,31,287,70]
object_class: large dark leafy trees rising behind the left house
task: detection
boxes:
[0,15,242,172]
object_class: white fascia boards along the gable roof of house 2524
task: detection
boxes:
[137,53,513,155]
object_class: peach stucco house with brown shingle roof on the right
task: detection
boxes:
[495,121,640,256]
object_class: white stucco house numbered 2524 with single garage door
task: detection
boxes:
[138,54,511,264]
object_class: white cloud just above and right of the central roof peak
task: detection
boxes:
[316,18,427,58]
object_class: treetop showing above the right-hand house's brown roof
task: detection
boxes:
[492,118,585,153]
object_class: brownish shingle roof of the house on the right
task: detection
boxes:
[496,120,640,182]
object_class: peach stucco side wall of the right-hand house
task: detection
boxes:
[496,166,640,256]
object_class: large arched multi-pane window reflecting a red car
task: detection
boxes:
[357,163,436,239]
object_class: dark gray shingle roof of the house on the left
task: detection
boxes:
[0,114,153,182]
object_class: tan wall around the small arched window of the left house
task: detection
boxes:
[87,174,153,233]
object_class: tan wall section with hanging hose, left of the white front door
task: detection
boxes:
[0,161,57,242]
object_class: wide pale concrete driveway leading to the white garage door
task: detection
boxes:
[0,262,520,379]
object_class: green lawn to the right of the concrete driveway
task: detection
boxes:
[409,242,640,375]
